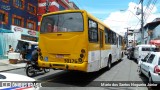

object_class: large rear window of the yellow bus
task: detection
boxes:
[40,12,84,33]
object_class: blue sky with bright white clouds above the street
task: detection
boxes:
[70,0,160,35]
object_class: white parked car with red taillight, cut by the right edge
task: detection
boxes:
[139,52,160,84]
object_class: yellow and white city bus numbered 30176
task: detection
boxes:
[38,10,123,72]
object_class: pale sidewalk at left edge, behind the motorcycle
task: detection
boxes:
[0,59,26,72]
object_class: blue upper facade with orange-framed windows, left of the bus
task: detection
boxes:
[0,0,38,30]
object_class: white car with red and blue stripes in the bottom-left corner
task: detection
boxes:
[0,73,40,90]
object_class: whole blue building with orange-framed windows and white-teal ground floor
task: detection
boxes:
[0,0,38,56]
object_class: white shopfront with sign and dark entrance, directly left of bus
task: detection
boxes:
[11,25,39,59]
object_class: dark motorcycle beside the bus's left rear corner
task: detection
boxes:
[25,61,50,77]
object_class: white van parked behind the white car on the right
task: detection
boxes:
[134,44,156,64]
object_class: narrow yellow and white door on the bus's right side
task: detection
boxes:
[100,30,104,68]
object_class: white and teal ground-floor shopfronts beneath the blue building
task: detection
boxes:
[0,25,39,57]
